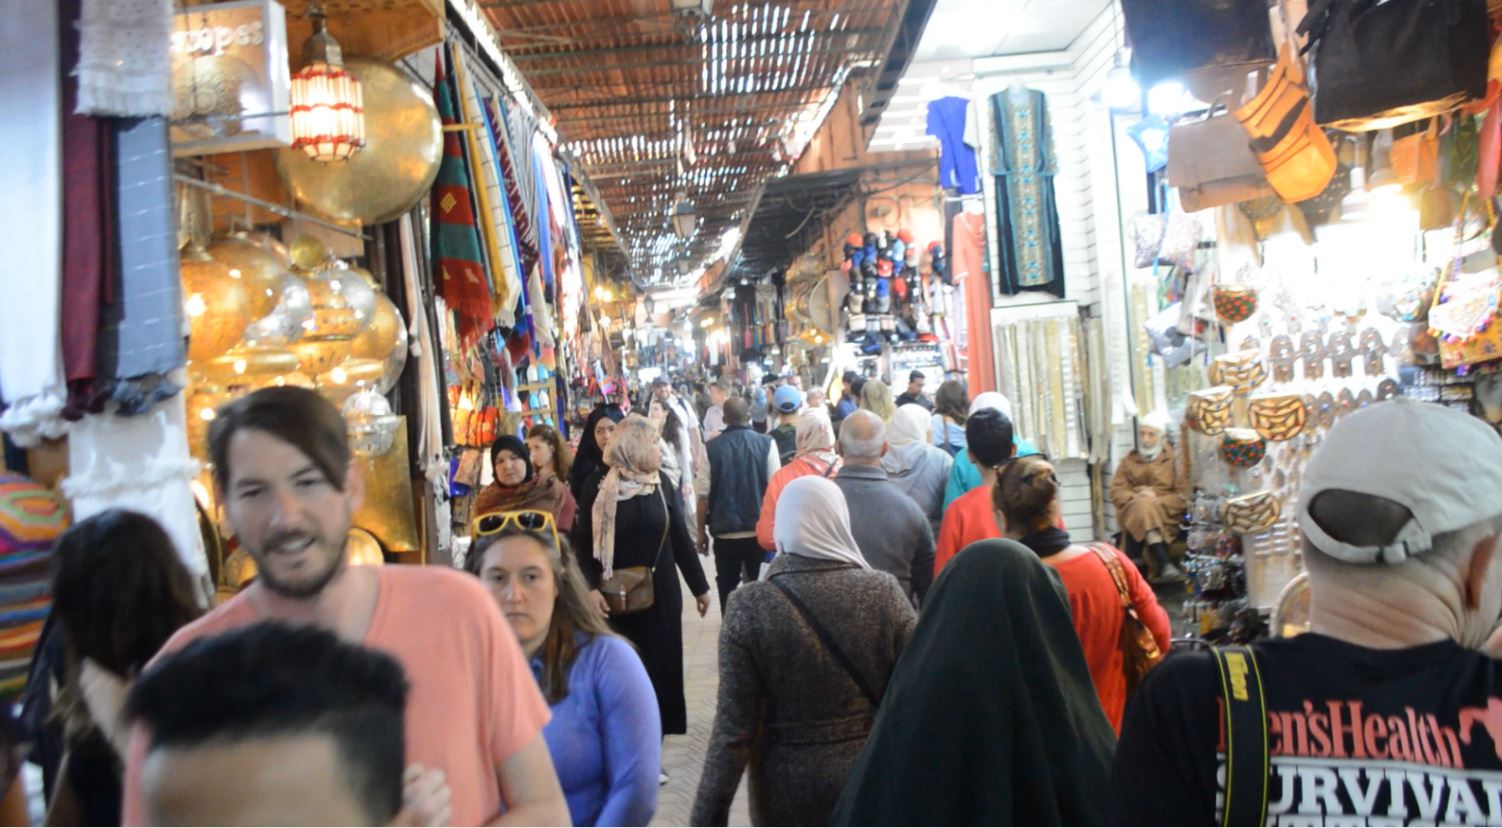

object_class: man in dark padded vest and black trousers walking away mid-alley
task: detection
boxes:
[698,397,781,615]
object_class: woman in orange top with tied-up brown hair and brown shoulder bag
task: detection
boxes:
[996,457,1172,733]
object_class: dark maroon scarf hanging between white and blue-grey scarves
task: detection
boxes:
[59,0,117,419]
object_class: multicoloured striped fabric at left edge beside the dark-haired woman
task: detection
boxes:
[0,475,68,702]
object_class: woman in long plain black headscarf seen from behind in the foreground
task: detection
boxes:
[831,539,1116,825]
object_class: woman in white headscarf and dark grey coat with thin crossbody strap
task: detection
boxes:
[689,476,916,825]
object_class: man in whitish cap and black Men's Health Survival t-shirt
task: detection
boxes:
[1110,400,1502,825]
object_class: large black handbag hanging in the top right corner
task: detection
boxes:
[1298,0,1491,131]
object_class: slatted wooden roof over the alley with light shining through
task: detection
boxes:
[479,0,907,284]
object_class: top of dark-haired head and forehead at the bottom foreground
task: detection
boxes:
[125,622,413,825]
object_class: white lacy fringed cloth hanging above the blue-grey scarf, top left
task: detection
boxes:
[73,0,173,117]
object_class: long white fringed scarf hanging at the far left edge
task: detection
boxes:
[0,0,65,446]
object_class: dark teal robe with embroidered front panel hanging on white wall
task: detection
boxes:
[991,87,1063,298]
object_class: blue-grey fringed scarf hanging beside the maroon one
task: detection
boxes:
[99,117,188,413]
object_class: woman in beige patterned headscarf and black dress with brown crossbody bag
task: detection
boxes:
[574,416,709,735]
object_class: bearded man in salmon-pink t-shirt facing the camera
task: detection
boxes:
[123,388,569,825]
